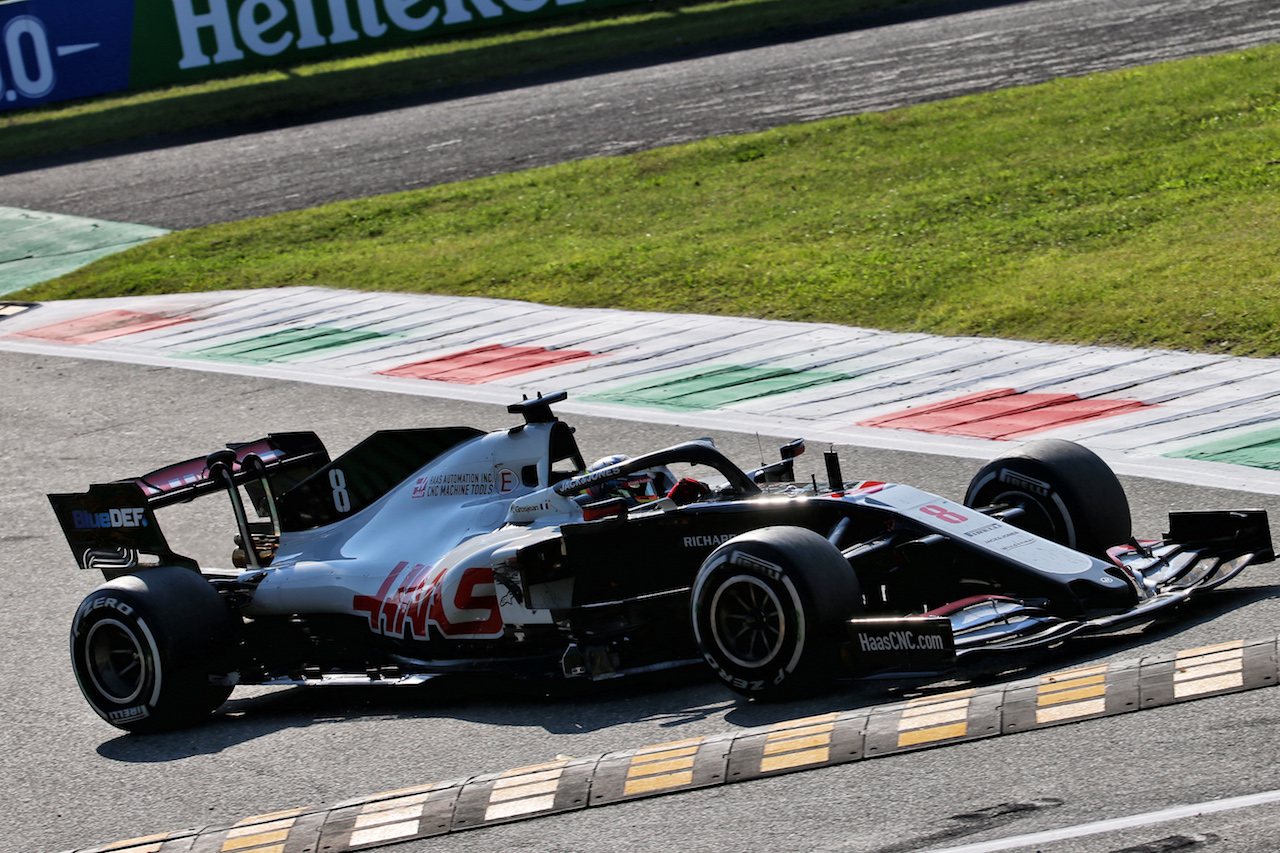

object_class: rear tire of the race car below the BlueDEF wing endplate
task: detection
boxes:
[70,566,241,733]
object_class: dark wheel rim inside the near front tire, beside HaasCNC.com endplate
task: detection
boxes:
[710,575,787,669]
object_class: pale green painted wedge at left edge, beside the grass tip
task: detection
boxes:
[0,207,169,295]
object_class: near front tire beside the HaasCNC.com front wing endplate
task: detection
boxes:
[691,526,863,702]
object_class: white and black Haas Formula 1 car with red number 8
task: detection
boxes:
[50,393,1274,731]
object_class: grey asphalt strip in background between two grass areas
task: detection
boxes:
[0,0,1280,229]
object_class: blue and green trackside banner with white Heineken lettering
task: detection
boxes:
[0,0,636,109]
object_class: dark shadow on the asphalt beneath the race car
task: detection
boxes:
[97,585,1280,763]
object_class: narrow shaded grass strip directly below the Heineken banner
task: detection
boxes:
[0,0,936,160]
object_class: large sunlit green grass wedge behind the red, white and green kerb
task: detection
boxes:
[15,47,1280,356]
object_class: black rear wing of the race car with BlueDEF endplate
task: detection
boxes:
[49,433,329,579]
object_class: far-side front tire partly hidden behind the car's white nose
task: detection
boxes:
[964,439,1133,558]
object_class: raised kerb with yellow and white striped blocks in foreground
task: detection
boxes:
[67,638,1280,853]
